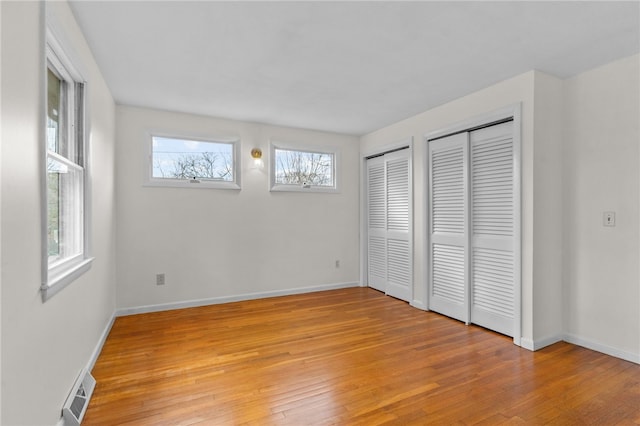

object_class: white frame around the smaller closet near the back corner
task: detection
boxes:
[360,137,416,309]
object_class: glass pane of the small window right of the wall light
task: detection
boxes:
[275,149,334,186]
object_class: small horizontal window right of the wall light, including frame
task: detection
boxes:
[271,143,338,192]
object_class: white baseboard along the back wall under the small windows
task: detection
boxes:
[115,282,360,317]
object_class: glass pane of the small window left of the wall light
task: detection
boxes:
[152,136,234,182]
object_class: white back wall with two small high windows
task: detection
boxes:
[116,106,359,312]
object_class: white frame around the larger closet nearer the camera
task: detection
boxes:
[422,103,522,346]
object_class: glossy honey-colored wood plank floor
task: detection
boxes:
[83,288,640,426]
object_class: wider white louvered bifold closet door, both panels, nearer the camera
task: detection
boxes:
[429,121,519,336]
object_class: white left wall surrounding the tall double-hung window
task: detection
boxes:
[0,2,115,425]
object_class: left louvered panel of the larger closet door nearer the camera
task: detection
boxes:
[429,133,469,323]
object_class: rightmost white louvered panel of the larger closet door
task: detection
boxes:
[470,122,515,336]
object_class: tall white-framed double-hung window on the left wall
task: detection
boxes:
[41,30,91,301]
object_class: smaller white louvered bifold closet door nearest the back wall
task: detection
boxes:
[367,149,413,301]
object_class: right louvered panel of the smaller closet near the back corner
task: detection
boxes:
[383,149,412,301]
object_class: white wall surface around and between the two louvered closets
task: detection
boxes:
[360,71,537,345]
